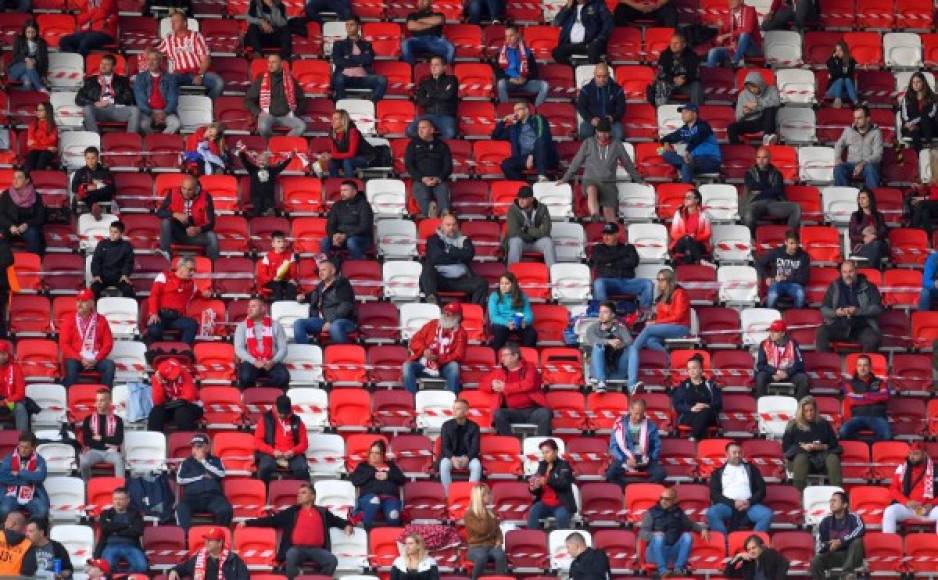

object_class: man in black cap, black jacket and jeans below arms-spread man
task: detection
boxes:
[593,222,655,308]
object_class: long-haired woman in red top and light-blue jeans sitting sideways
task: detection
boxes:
[628,268,690,393]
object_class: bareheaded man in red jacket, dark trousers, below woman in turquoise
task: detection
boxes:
[481,344,553,437]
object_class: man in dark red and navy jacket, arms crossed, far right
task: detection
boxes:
[840,354,892,441]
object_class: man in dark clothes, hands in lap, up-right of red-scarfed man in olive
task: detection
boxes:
[332,16,388,103]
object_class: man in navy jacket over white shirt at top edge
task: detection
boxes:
[552,0,612,64]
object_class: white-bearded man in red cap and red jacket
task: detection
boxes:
[401,302,468,394]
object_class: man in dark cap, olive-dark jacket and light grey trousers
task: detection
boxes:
[502,185,557,268]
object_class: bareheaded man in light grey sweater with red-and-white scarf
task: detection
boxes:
[234,298,290,390]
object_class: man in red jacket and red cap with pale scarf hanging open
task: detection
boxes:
[59,288,115,387]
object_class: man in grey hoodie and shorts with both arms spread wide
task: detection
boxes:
[557,116,642,222]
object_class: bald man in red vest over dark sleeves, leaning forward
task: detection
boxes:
[156,175,218,260]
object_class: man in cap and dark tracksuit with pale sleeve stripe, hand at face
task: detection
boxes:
[176,433,234,531]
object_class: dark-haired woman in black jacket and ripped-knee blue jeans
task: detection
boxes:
[349,439,407,530]
